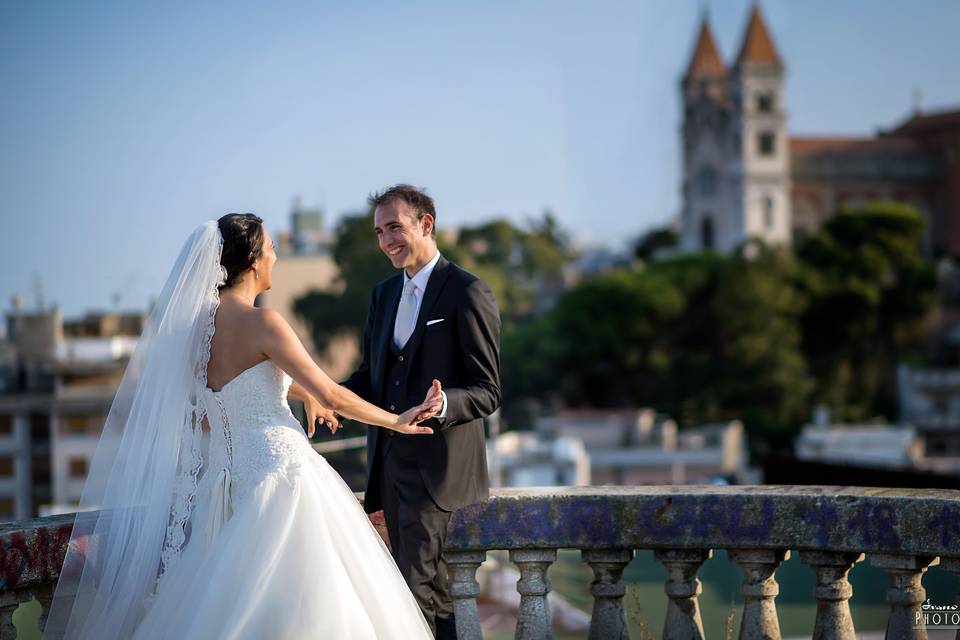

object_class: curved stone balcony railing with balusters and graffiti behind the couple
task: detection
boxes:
[0,486,960,640]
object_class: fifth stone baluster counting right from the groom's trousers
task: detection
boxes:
[729,549,790,640]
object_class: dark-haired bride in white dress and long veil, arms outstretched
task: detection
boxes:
[44,214,442,640]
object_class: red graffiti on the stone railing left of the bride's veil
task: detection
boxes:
[0,524,73,590]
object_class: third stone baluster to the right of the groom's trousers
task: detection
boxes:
[580,549,633,640]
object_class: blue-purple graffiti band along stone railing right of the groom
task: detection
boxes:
[451,492,960,550]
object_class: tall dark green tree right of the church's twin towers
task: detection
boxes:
[798,202,936,420]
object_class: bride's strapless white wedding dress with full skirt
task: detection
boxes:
[135,360,432,640]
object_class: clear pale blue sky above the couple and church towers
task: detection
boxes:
[0,0,960,315]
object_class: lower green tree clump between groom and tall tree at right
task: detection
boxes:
[504,245,810,446]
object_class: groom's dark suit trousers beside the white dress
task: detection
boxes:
[380,434,457,640]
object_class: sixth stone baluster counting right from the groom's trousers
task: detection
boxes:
[800,551,863,640]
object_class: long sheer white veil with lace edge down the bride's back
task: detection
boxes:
[44,222,225,640]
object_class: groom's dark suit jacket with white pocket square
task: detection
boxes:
[343,256,500,513]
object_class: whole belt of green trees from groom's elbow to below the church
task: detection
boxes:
[504,203,936,451]
